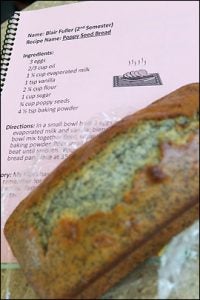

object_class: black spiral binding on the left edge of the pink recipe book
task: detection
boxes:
[1,11,20,92]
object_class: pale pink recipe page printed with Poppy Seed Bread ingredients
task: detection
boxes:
[1,1,199,262]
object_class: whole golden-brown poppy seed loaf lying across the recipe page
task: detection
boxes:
[5,83,199,299]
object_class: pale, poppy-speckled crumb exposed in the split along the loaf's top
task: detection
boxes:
[30,115,198,247]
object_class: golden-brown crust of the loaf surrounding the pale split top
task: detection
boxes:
[5,84,199,299]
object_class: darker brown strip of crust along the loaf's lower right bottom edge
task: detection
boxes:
[74,199,199,299]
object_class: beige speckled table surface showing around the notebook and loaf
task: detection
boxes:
[1,1,199,299]
